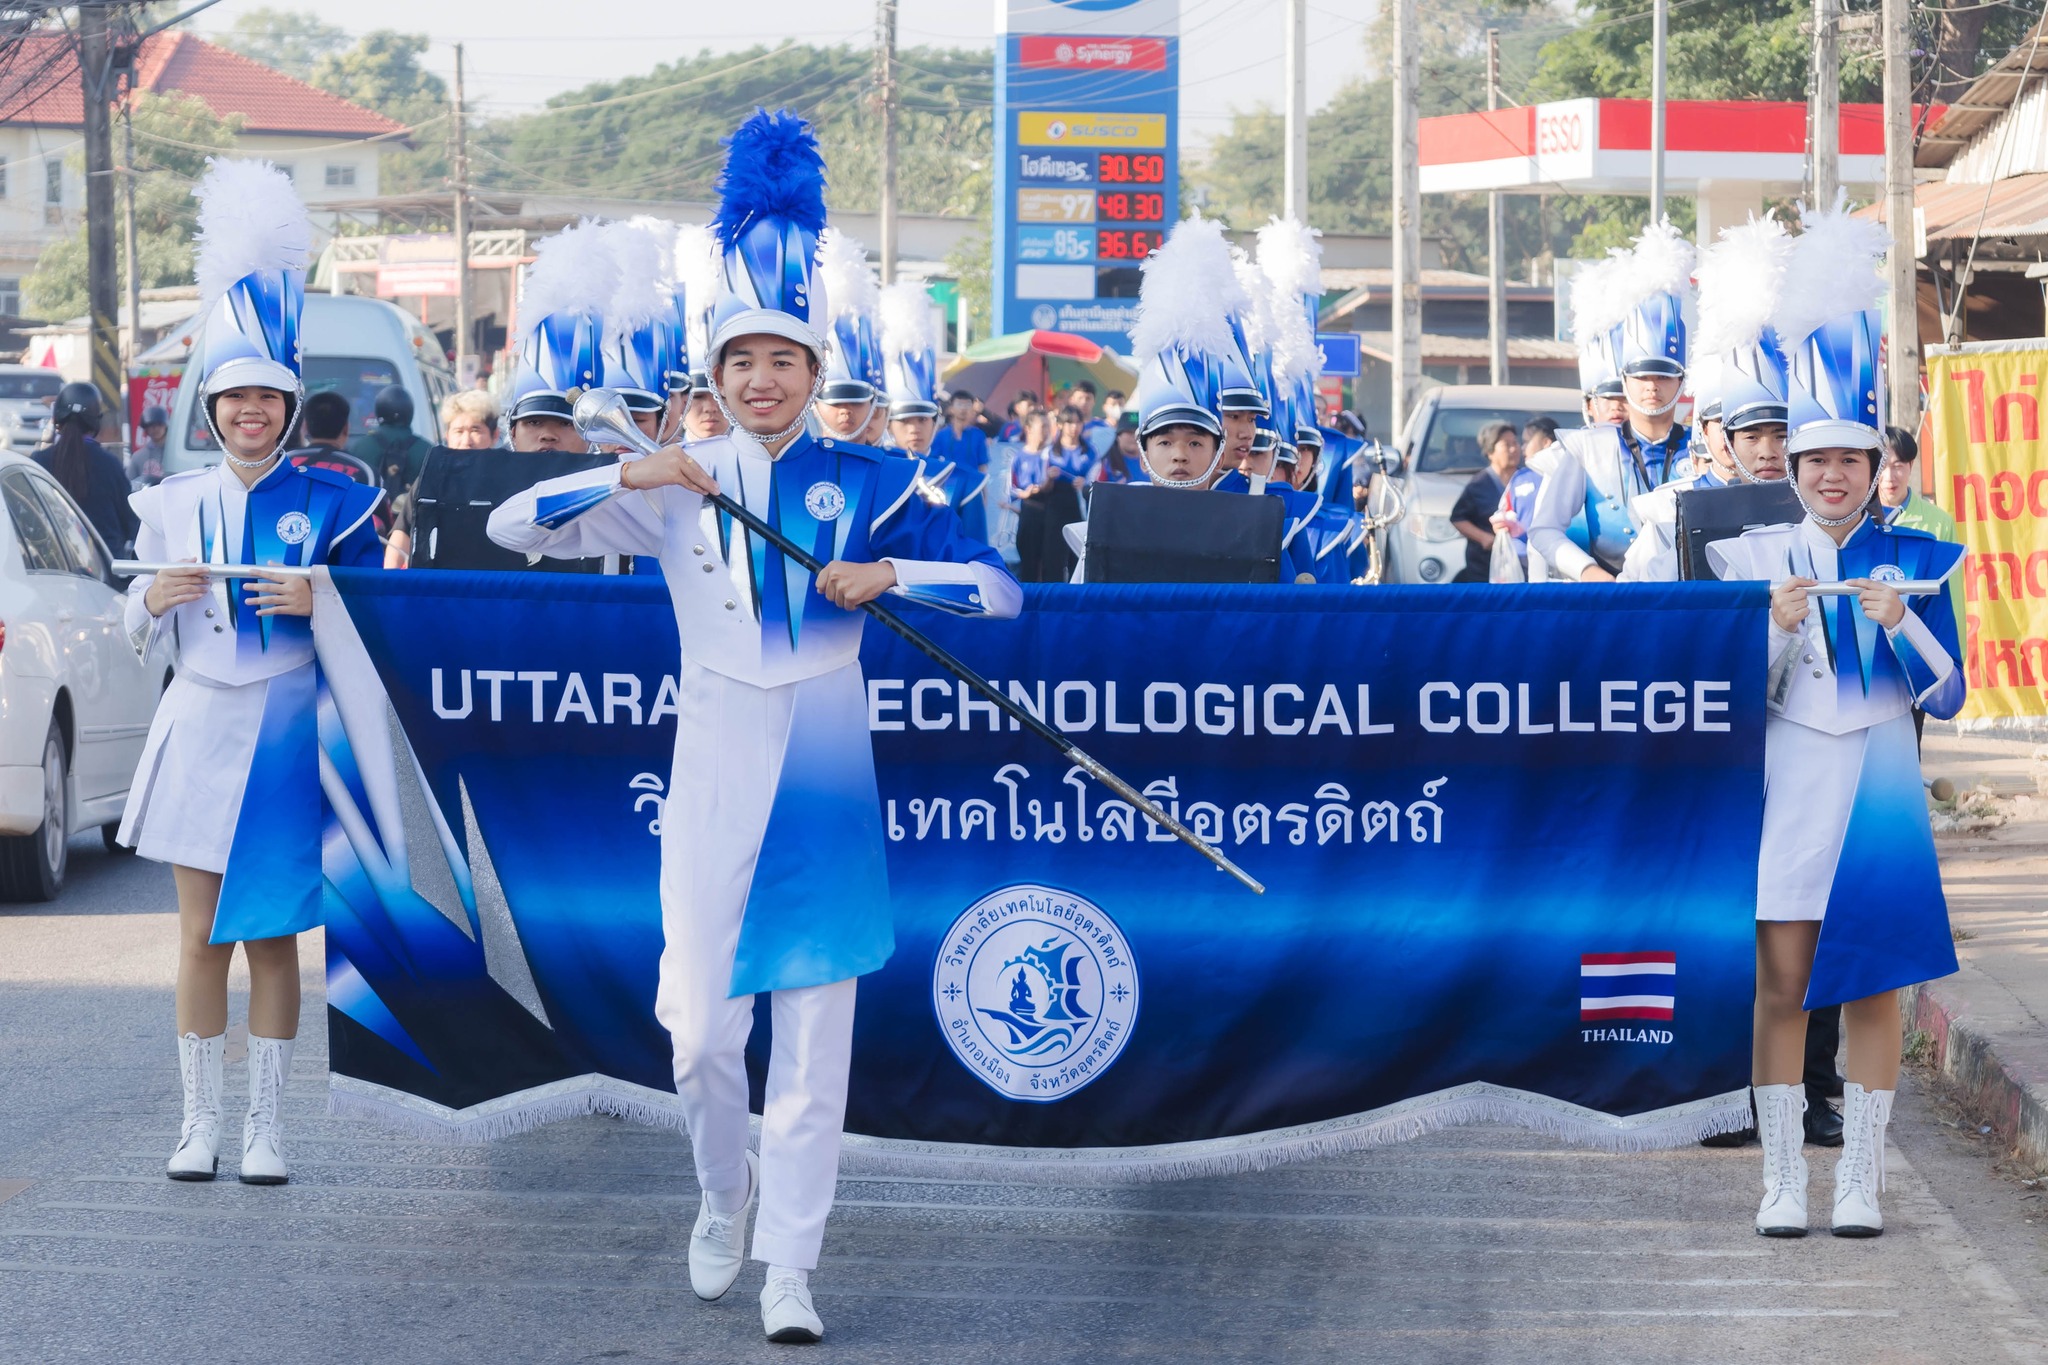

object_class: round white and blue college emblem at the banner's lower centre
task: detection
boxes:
[932,884,1139,1103]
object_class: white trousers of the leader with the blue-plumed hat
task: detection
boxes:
[655,661,854,1271]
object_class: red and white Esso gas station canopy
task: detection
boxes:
[1421,100,1884,194]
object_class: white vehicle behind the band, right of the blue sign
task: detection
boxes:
[1386,385,1583,583]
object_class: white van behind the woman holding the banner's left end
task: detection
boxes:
[164,293,455,473]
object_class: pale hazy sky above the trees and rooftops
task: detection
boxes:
[193,0,1372,143]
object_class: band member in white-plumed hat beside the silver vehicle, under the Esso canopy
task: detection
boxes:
[1530,221,1692,583]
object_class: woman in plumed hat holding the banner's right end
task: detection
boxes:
[1708,209,1966,1236]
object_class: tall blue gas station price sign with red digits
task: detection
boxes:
[993,0,1180,352]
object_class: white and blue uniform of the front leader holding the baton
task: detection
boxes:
[489,430,1022,1269]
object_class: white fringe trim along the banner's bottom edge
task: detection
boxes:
[328,1074,1751,1185]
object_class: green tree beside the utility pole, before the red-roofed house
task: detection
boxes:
[27,92,242,317]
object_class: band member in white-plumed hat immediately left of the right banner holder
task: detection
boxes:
[1620,215,1792,583]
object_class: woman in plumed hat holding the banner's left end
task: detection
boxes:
[119,160,383,1185]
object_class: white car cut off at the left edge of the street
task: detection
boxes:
[0,452,172,900]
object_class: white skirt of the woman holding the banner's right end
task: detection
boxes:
[1757,716,1868,921]
